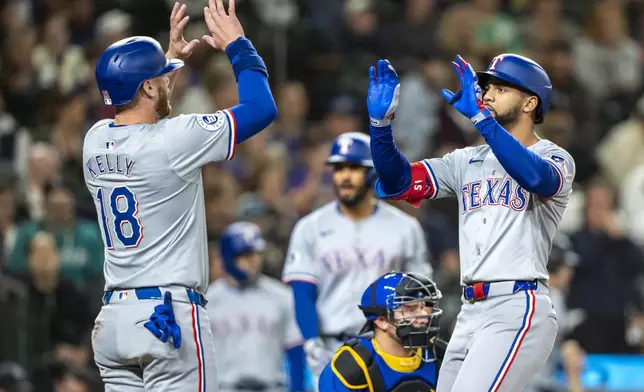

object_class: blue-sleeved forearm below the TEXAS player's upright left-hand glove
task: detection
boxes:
[369,125,411,197]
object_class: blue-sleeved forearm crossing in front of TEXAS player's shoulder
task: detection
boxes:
[476,117,561,197]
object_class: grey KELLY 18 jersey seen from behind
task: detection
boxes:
[83,110,235,290]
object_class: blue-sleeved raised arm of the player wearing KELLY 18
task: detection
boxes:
[226,37,277,143]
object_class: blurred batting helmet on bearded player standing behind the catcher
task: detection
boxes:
[326,132,376,185]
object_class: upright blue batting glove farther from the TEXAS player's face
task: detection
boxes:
[367,60,400,127]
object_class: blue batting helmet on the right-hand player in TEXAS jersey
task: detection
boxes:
[476,53,552,124]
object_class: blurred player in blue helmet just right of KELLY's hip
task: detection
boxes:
[206,222,305,392]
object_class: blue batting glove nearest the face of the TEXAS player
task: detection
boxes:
[441,55,492,124]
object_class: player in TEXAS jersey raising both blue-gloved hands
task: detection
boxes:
[367,54,575,392]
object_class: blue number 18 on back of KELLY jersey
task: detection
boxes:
[96,186,143,250]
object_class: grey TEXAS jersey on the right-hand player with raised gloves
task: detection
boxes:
[422,139,575,284]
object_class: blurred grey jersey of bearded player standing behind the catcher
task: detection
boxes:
[283,202,432,335]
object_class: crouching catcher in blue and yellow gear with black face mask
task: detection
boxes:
[320,272,446,392]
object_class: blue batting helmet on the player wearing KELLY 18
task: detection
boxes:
[96,37,183,106]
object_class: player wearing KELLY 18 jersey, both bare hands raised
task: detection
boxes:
[83,0,277,391]
